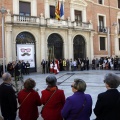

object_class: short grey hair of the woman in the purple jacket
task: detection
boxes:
[73,79,87,92]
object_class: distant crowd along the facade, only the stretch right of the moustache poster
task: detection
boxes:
[41,56,120,74]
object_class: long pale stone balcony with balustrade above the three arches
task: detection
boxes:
[5,14,92,30]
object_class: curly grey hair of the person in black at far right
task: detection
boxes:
[104,73,120,88]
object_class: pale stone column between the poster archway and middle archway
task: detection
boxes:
[40,28,46,60]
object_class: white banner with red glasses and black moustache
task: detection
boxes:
[17,44,35,68]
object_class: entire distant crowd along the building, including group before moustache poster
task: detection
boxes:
[0,56,120,77]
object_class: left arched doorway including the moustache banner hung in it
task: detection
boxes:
[16,32,36,72]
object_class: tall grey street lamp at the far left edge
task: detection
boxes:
[0,6,7,73]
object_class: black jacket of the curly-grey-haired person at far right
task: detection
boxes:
[94,89,120,120]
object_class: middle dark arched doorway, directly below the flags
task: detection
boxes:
[48,33,63,60]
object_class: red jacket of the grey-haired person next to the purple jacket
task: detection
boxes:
[41,88,65,120]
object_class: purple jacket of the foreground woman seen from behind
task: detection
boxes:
[61,92,92,120]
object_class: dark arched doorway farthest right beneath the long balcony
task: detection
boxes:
[73,35,86,59]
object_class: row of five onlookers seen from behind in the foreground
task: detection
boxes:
[0,73,120,120]
